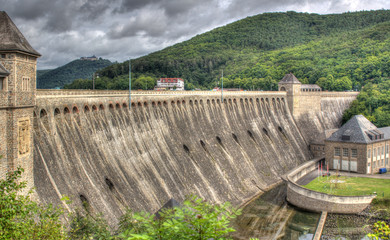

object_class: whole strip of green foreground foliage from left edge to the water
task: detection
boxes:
[0,168,241,240]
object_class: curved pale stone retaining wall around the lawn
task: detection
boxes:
[285,158,376,214]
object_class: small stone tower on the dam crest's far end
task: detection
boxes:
[278,73,302,115]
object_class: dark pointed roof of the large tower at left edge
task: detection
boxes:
[0,11,41,57]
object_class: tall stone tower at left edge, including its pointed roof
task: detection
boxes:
[0,11,40,187]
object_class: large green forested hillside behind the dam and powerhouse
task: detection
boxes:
[66,10,390,126]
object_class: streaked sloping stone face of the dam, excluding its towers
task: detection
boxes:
[33,92,356,224]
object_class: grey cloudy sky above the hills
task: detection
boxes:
[0,0,390,69]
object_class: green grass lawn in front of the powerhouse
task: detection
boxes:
[303,176,390,198]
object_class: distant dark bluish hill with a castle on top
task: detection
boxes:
[37,59,112,89]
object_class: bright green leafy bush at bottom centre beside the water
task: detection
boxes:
[118,196,241,240]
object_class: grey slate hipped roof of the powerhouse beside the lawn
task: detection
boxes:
[327,115,390,143]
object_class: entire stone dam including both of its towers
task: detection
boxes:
[0,12,357,229]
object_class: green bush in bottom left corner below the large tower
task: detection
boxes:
[0,168,66,240]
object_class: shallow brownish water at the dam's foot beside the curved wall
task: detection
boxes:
[234,183,320,240]
